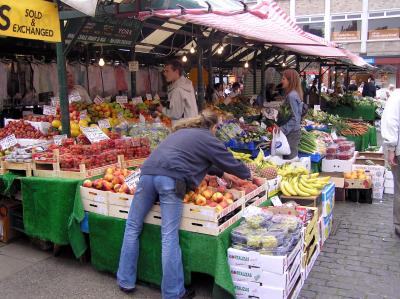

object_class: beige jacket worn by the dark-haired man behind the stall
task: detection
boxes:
[163,76,199,123]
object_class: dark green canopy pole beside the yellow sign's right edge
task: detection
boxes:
[56,8,71,137]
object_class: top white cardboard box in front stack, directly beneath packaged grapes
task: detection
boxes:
[228,242,303,275]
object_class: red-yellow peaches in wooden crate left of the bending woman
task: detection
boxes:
[82,167,135,195]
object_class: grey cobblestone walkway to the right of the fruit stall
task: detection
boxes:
[300,197,400,299]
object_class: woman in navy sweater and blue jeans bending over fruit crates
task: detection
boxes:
[117,110,251,299]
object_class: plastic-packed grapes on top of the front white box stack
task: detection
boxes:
[231,208,303,256]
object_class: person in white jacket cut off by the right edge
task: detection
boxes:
[381,89,400,237]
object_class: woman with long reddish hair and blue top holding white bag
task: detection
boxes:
[280,69,304,159]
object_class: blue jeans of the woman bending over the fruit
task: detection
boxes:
[117,175,185,299]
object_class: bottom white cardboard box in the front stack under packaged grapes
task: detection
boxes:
[233,266,302,299]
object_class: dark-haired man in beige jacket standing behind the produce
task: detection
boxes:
[158,59,199,124]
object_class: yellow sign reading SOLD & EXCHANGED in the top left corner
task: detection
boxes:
[0,0,61,42]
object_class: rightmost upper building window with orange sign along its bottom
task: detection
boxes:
[368,17,400,40]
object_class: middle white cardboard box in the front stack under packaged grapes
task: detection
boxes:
[230,252,302,290]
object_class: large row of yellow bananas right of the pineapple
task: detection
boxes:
[280,173,330,197]
